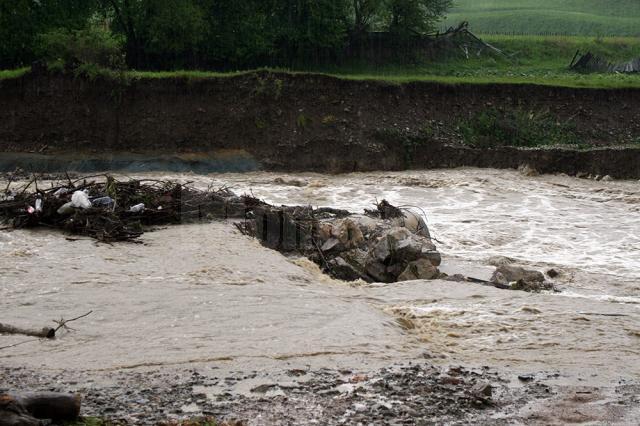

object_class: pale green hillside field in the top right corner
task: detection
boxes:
[442,0,640,36]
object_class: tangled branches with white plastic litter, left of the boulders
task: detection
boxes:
[0,176,261,242]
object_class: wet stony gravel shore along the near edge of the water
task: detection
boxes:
[0,364,550,425]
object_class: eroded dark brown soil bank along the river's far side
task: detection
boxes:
[0,72,640,178]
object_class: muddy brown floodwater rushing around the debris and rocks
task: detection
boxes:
[0,169,640,385]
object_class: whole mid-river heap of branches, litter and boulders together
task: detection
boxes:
[0,175,441,282]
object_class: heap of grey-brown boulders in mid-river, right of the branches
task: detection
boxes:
[246,200,441,282]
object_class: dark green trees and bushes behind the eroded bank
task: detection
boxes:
[0,0,452,69]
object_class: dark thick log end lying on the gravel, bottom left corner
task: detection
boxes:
[0,392,82,426]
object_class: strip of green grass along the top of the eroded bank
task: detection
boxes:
[0,36,640,88]
